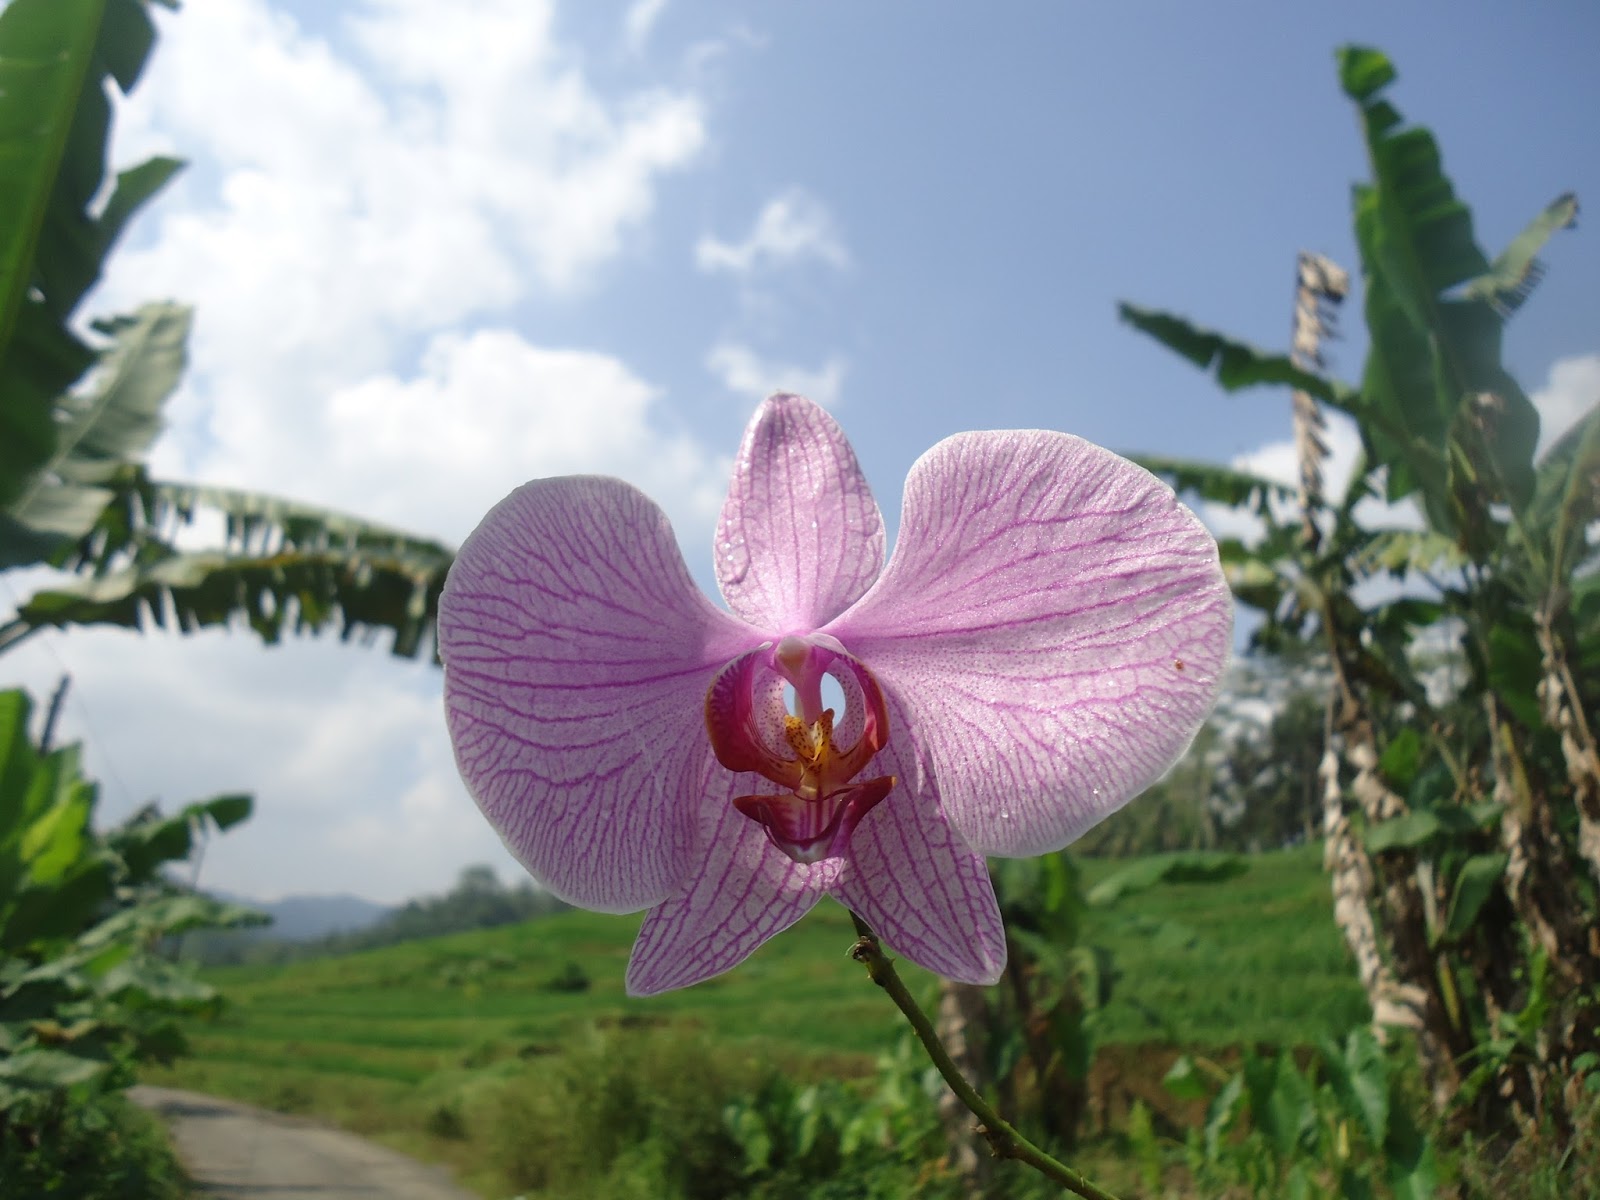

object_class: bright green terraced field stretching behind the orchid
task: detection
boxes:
[147,846,1365,1194]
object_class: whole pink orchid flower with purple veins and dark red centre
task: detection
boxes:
[438,395,1232,995]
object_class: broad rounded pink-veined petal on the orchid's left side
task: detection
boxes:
[438,477,758,912]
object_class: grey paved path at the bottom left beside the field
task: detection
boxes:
[128,1086,474,1200]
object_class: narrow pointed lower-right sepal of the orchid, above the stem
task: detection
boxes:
[832,706,1005,984]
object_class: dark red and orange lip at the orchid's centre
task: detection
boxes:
[706,635,894,862]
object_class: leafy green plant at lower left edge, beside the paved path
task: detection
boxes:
[0,691,254,1136]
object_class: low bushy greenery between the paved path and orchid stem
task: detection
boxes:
[464,1029,1034,1200]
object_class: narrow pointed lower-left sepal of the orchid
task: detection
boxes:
[627,771,840,995]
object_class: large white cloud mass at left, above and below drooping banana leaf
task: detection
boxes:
[6,0,726,899]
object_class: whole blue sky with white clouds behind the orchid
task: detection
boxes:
[6,0,1600,899]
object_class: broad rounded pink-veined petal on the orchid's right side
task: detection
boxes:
[824,430,1234,858]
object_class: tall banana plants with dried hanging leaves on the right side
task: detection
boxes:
[1122,48,1600,1130]
